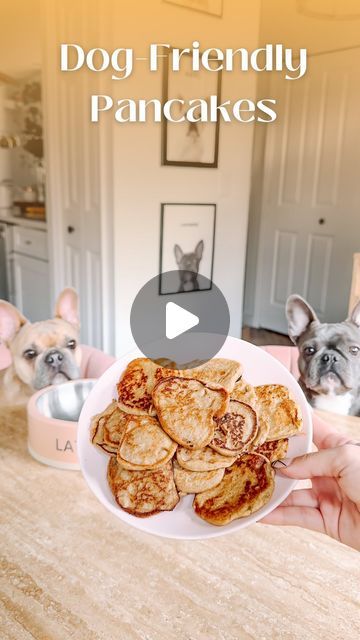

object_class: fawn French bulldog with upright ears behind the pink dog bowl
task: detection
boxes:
[0,289,81,405]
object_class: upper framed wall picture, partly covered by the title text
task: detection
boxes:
[161,48,222,168]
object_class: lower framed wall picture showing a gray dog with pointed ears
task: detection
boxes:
[159,203,216,295]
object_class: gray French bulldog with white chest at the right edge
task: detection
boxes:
[286,295,360,416]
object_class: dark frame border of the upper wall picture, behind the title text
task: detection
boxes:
[161,47,222,169]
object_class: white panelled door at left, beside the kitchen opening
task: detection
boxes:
[43,0,113,352]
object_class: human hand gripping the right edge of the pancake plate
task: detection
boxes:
[261,418,360,550]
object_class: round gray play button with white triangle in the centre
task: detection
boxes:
[130,270,230,369]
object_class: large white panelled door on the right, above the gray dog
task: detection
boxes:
[255,49,360,332]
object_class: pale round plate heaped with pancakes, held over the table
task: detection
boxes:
[78,337,312,540]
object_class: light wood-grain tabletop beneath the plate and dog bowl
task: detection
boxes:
[0,409,360,640]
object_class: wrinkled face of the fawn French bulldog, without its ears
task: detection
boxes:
[10,318,81,389]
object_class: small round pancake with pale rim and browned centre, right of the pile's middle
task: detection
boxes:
[210,400,258,457]
